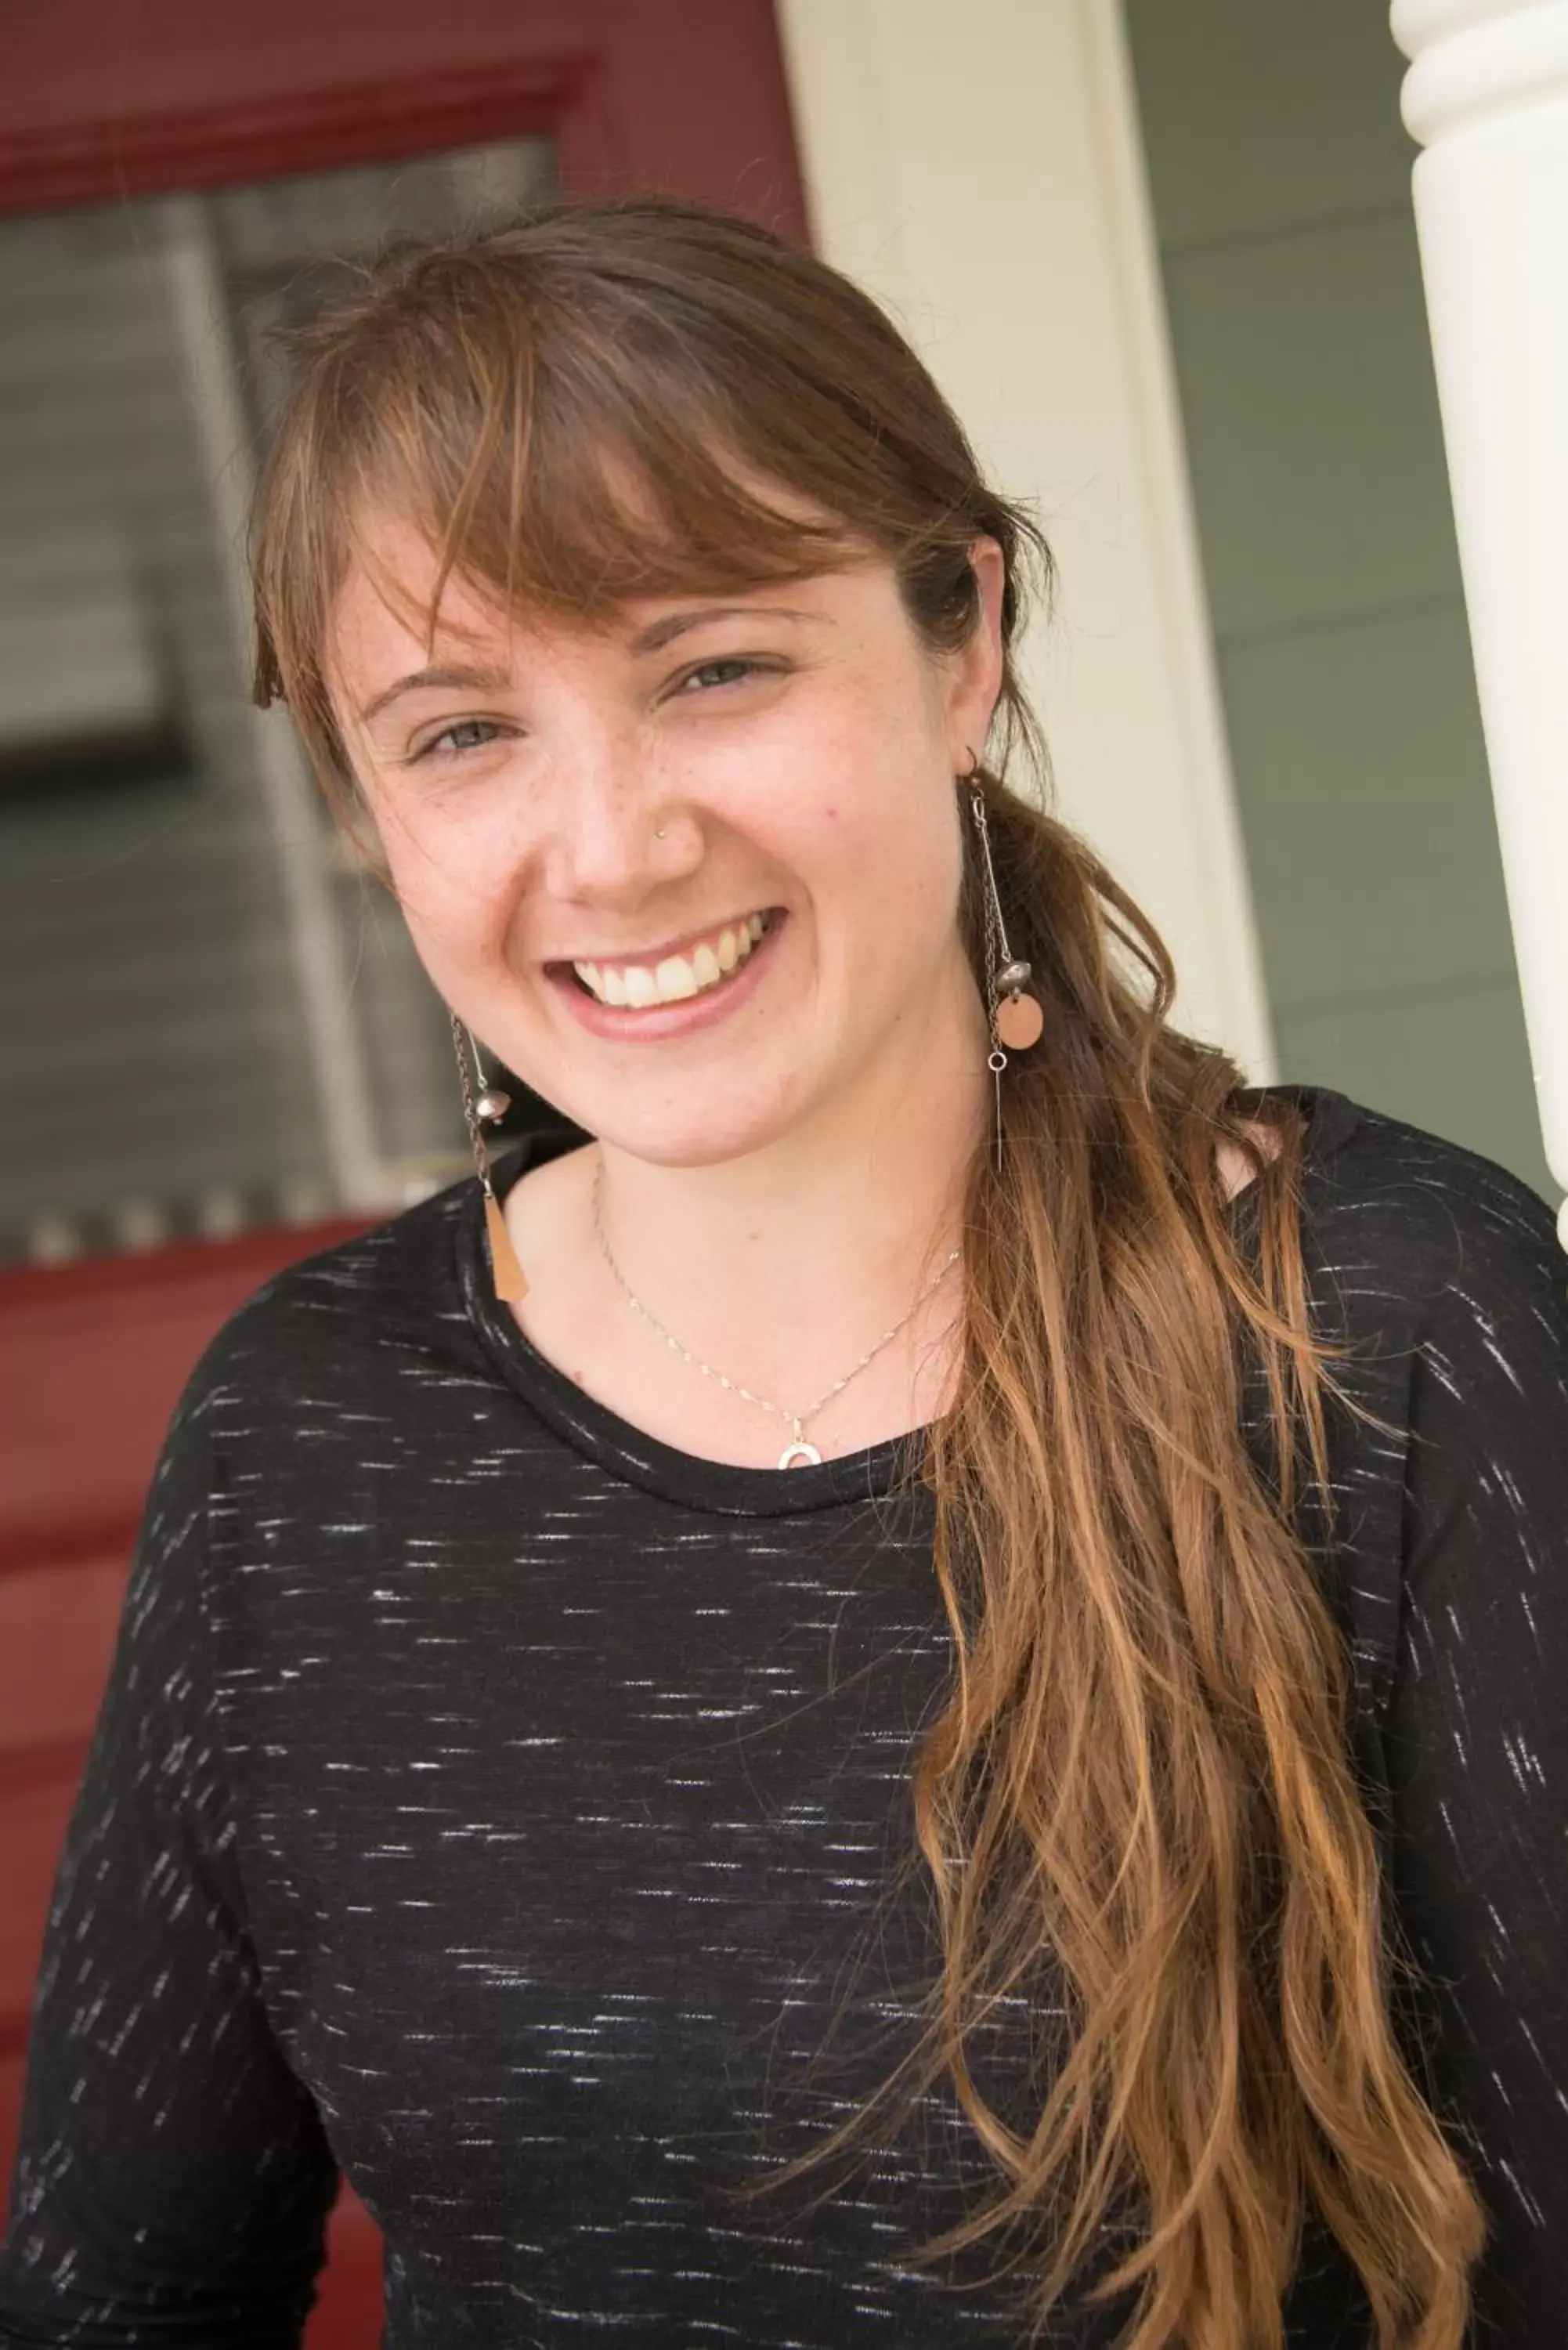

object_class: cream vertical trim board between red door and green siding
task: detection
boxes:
[778,0,1277,1081]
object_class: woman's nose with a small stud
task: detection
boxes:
[538,738,703,907]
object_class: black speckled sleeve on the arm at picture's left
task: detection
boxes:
[0,1389,336,2350]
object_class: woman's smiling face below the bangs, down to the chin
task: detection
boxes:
[329,517,1002,1166]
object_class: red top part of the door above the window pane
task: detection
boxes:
[0,0,807,242]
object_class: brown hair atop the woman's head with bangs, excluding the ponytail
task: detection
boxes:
[251,200,1037,790]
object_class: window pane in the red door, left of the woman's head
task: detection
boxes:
[0,141,555,1257]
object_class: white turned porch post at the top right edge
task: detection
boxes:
[1392,0,1568,1248]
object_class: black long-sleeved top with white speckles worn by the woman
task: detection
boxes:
[0,1088,1568,2350]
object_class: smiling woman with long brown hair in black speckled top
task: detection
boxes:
[0,202,1568,2350]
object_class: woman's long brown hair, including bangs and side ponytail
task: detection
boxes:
[254,200,1483,2350]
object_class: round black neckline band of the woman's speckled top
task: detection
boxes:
[453,1086,1357,1518]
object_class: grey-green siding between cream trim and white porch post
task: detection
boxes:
[1126,0,1559,1198]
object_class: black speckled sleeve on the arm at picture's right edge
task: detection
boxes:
[1385,1170,1568,2350]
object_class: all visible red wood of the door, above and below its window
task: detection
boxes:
[0,0,807,2350]
